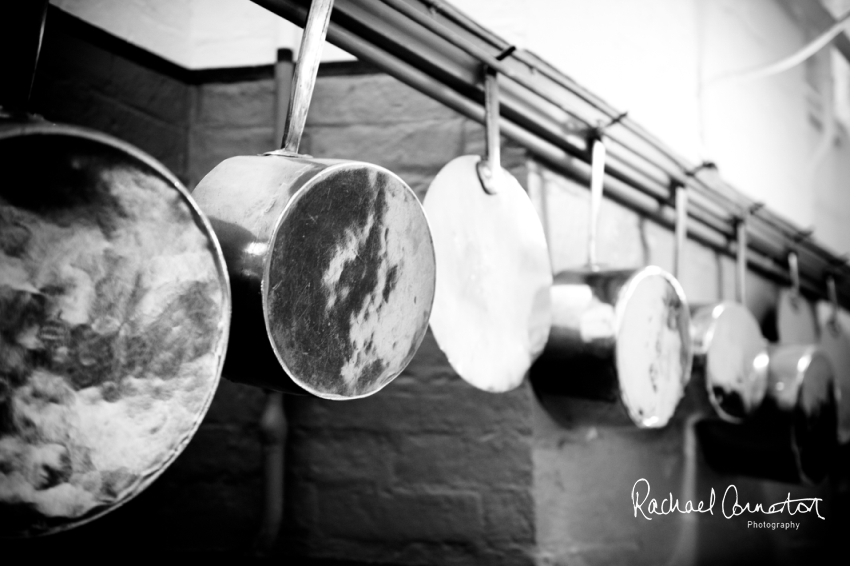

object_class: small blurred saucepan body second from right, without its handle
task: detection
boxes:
[691,302,768,422]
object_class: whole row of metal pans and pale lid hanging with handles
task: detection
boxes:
[0,0,837,536]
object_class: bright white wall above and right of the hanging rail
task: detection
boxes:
[452,0,850,253]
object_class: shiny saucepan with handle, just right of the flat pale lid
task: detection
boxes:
[533,137,692,428]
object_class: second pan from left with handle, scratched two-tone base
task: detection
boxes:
[192,0,435,400]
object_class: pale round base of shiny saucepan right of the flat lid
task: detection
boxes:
[616,266,693,428]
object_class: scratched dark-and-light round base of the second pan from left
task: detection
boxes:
[263,162,435,399]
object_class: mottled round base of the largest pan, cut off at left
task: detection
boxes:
[0,123,230,536]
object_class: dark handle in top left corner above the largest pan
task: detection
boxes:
[0,0,48,114]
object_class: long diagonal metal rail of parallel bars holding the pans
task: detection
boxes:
[252,0,850,308]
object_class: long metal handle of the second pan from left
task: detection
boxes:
[282,0,333,154]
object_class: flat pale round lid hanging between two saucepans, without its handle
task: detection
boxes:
[425,155,552,392]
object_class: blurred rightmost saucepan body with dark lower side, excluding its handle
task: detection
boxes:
[767,346,838,483]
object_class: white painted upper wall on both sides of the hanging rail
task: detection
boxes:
[51,0,850,253]
